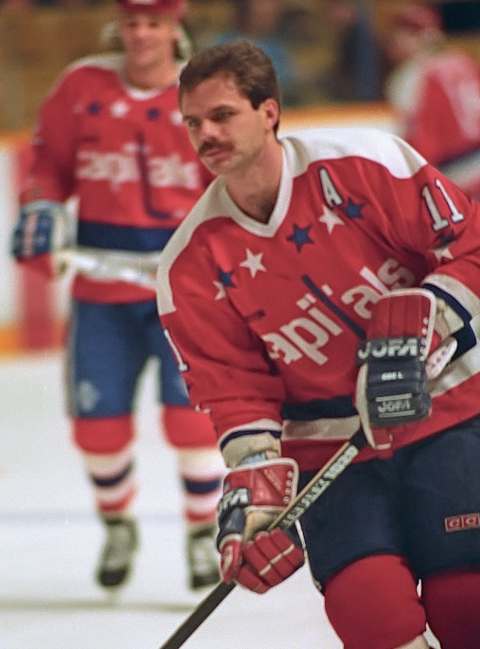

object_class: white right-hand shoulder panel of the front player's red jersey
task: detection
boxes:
[281,128,426,178]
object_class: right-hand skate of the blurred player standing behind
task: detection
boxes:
[187,525,220,590]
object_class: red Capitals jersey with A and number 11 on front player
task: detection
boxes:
[158,129,480,468]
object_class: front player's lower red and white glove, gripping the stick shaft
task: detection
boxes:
[217,458,305,593]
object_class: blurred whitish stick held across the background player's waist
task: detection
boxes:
[55,246,161,290]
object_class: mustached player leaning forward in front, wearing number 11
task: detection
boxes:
[158,42,480,649]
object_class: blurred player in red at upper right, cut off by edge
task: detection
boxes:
[386,4,480,199]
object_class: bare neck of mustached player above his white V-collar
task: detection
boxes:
[225,140,283,223]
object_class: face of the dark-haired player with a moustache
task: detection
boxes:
[181,74,278,175]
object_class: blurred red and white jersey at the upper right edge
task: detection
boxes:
[387,50,480,198]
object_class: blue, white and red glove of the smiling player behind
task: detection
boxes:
[11,200,70,277]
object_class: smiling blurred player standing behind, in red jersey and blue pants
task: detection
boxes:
[13,0,224,588]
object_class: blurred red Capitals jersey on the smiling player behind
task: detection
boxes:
[21,54,211,302]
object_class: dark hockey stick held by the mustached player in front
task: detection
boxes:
[159,429,367,649]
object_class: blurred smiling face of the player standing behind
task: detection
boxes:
[119,11,177,68]
